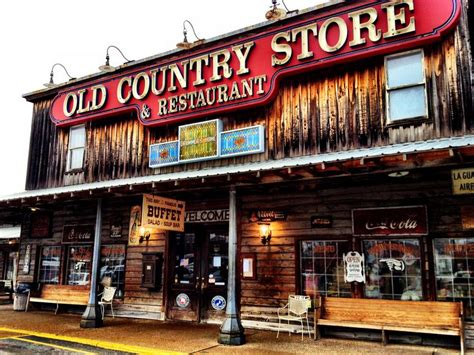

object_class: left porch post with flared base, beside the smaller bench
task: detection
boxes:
[81,198,102,328]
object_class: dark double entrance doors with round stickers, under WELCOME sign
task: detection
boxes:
[167,226,229,322]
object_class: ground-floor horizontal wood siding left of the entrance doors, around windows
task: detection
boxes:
[15,198,166,319]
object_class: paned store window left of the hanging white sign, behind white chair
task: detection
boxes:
[300,240,352,297]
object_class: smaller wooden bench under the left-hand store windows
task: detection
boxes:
[25,285,89,314]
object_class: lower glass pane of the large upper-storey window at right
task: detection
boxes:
[389,85,426,121]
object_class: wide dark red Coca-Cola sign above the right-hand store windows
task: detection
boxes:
[352,206,428,236]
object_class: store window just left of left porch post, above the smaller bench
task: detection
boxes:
[66,245,92,286]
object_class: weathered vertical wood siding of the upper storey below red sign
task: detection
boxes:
[26,5,474,189]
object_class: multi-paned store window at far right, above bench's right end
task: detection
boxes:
[433,238,474,320]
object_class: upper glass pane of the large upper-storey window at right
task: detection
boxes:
[387,52,425,88]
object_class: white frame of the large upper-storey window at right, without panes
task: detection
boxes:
[384,48,429,127]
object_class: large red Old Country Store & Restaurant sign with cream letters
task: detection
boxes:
[50,0,460,126]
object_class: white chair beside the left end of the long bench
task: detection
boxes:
[277,295,311,340]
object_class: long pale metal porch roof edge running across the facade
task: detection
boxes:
[0,135,474,202]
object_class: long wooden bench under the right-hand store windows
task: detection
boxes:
[314,297,464,354]
